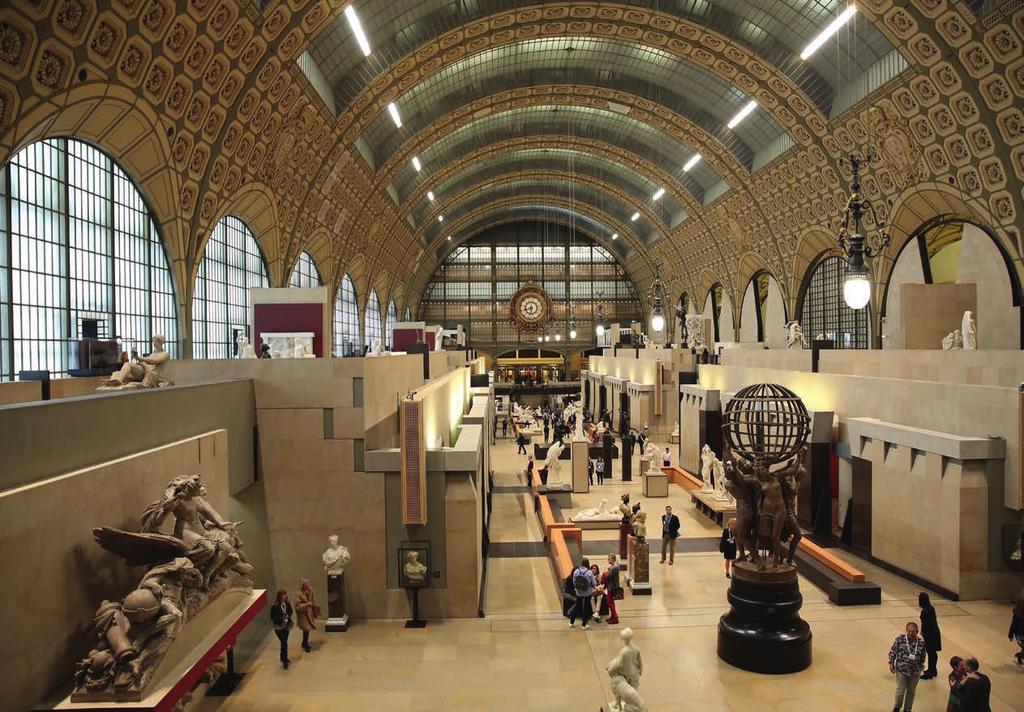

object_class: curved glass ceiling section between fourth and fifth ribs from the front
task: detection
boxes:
[423,178,660,245]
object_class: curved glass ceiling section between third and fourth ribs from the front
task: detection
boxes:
[412,149,686,227]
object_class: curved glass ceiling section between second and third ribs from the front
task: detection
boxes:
[394,106,722,203]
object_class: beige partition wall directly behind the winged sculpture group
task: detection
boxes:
[0,430,228,710]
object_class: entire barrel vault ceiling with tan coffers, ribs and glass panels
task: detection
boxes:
[0,0,1024,317]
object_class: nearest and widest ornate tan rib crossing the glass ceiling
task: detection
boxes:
[327,2,827,151]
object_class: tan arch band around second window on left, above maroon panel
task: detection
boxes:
[198,181,284,290]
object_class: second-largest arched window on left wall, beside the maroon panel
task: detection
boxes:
[193,210,270,359]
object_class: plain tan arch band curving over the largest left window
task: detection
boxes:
[0,84,193,301]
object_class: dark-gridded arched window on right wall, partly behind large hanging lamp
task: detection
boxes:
[800,256,867,348]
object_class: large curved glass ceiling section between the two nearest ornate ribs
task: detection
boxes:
[361,37,783,168]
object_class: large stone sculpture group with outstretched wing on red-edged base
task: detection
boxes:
[72,474,253,702]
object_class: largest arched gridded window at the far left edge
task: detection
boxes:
[0,138,178,380]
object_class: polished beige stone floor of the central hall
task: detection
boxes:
[199,441,1024,712]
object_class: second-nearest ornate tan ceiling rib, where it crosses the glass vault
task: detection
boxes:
[377,84,751,187]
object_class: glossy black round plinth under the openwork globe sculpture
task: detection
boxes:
[718,561,811,675]
